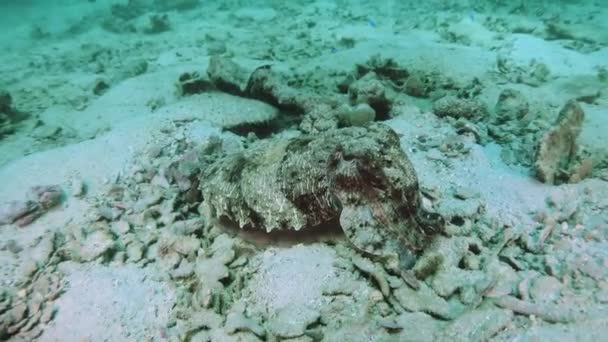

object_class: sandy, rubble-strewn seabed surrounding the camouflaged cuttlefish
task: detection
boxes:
[0,0,608,341]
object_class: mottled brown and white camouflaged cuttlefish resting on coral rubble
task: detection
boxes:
[200,124,443,262]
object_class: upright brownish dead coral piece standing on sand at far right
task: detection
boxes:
[534,100,585,184]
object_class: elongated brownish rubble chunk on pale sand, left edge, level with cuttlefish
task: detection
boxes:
[0,185,63,226]
